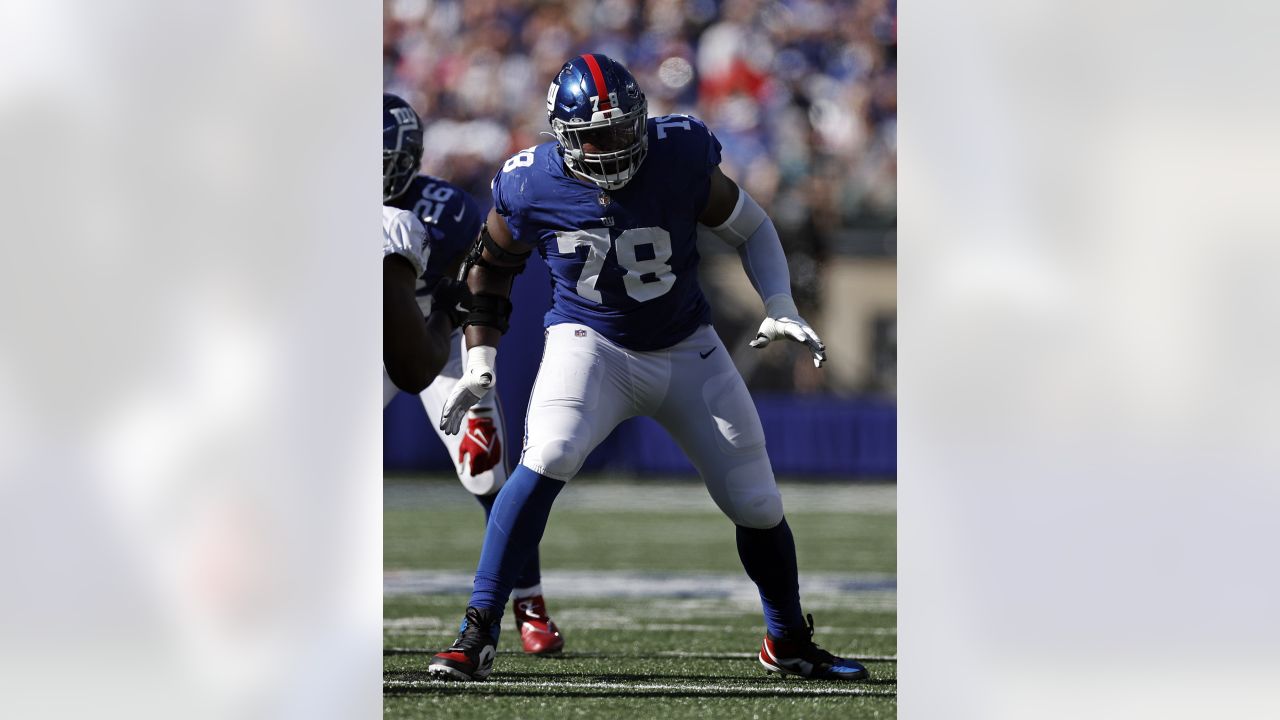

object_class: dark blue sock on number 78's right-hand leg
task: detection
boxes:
[737,518,805,638]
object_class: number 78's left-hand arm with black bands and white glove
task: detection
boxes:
[440,210,532,436]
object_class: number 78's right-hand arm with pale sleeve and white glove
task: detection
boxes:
[698,168,827,368]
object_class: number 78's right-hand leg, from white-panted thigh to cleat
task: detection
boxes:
[654,327,867,680]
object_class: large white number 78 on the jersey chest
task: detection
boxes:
[556,228,676,302]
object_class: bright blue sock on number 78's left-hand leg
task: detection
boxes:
[468,465,564,616]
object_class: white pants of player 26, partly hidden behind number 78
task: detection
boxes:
[383,331,507,495]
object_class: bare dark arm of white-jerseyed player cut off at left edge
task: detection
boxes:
[383,255,452,393]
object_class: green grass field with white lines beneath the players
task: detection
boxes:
[383,478,897,720]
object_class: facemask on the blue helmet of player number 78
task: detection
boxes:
[552,99,649,190]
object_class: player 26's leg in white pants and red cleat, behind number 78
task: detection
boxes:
[420,332,564,655]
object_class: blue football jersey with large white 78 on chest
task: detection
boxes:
[493,115,721,351]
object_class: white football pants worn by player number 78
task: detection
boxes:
[520,324,782,528]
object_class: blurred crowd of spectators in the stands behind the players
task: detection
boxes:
[383,0,897,392]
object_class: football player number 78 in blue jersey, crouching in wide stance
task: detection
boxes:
[429,54,868,680]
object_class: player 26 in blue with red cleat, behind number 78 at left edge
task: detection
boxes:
[383,94,564,655]
